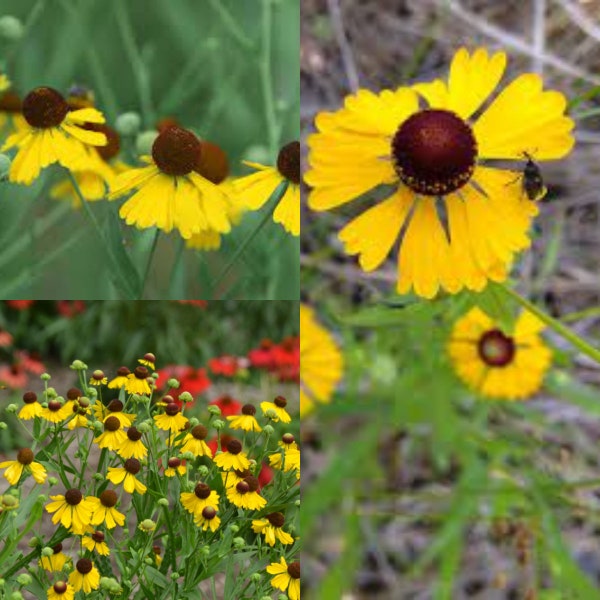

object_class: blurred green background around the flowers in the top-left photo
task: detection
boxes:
[0,0,299,299]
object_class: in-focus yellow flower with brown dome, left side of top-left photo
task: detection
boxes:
[0,87,107,185]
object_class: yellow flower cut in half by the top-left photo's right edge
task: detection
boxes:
[233,142,300,236]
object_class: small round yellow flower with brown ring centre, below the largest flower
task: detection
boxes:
[448,308,552,400]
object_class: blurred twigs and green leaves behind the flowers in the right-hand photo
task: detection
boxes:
[301,0,600,600]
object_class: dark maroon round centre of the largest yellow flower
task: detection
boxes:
[392,109,477,196]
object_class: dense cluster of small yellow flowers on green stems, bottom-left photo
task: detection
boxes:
[0,353,300,600]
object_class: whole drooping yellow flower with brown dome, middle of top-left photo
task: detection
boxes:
[109,127,231,239]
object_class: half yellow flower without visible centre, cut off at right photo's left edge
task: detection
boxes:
[300,304,344,416]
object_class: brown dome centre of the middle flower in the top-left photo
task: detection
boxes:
[152,127,201,175]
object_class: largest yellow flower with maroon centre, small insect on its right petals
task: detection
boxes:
[305,48,574,298]
